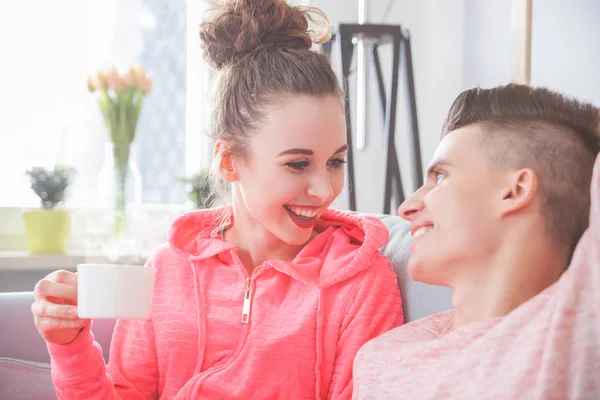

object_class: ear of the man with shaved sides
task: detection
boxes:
[500,168,538,216]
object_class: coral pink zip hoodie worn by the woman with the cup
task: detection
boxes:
[48,208,402,400]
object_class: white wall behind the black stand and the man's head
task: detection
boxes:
[322,0,600,216]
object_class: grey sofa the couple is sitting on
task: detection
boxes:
[0,215,452,400]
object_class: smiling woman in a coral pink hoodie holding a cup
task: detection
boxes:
[32,0,402,400]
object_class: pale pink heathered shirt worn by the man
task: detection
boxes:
[354,158,600,400]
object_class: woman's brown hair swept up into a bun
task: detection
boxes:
[200,0,341,200]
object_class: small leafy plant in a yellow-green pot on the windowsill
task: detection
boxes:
[23,165,74,253]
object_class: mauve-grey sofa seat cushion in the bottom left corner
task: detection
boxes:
[0,357,56,400]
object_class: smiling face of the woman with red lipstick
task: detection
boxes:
[227,96,348,245]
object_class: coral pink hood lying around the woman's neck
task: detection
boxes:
[169,206,389,288]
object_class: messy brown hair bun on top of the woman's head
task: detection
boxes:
[200,0,330,69]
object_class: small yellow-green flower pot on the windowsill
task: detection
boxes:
[23,209,71,254]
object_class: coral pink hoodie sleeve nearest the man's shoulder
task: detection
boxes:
[327,257,404,400]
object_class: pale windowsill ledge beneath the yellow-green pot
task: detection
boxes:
[0,251,146,271]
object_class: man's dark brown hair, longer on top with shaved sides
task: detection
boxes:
[442,84,600,258]
